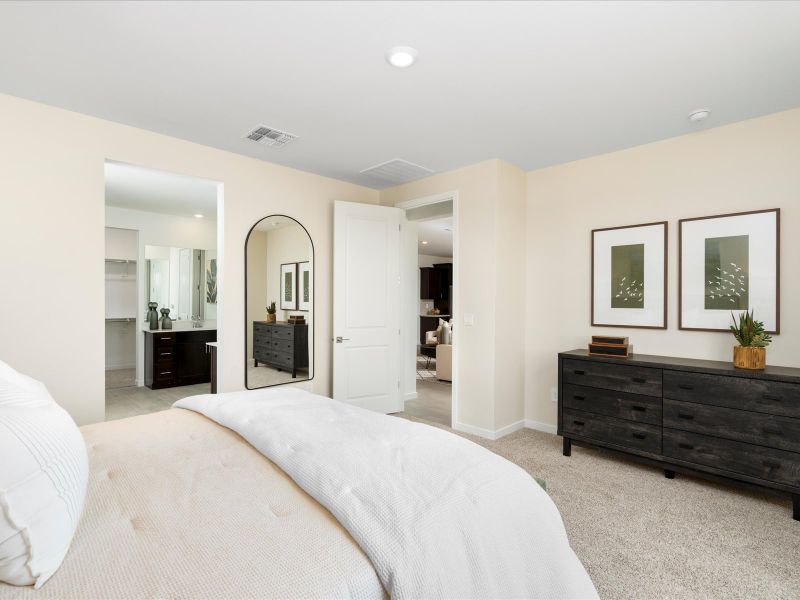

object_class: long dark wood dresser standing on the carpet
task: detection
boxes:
[558,350,800,520]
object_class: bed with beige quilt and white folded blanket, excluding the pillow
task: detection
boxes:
[0,388,596,599]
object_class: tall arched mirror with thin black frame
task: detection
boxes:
[245,215,314,390]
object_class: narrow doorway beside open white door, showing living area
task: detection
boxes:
[397,192,458,427]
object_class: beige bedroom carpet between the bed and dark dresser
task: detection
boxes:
[399,413,800,600]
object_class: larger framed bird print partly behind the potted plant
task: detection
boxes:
[678,208,780,333]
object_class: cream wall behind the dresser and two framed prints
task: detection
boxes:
[525,109,800,426]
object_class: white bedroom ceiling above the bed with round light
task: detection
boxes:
[0,2,800,187]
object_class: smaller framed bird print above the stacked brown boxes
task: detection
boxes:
[592,221,667,329]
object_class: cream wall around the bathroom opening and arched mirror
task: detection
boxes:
[0,95,378,424]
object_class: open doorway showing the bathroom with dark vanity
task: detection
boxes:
[105,161,222,420]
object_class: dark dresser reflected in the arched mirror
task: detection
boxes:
[253,321,308,378]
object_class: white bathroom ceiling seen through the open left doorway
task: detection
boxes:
[105,161,218,219]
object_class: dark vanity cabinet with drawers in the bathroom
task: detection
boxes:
[144,329,217,390]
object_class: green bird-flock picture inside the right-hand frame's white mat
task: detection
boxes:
[705,235,750,310]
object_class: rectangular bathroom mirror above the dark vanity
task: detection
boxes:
[144,246,217,321]
